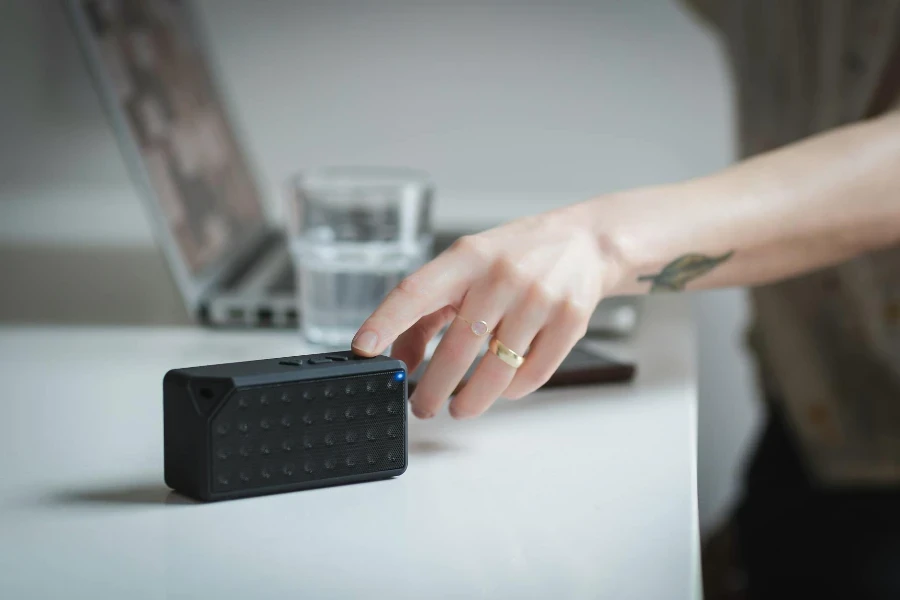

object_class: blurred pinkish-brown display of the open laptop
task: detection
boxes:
[82,0,264,274]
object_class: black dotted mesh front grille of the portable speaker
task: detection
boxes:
[210,371,406,493]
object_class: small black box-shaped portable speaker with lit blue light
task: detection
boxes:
[163,352,407,501]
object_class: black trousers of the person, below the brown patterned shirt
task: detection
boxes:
[734,404,900,600]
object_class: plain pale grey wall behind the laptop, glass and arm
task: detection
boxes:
[0,0,758,531]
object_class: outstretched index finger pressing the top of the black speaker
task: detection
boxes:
[351,251,473,356]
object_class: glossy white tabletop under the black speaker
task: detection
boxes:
[0,297,699,600]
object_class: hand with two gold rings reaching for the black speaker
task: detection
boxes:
[353,208,620,418]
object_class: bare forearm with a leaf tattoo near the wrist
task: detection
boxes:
[572,115,900,295]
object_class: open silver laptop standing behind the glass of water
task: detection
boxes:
[62,0,640,335]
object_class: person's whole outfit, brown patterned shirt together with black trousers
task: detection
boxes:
[687,0,900,600]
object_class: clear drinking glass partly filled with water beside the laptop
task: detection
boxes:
[288,167,433,348]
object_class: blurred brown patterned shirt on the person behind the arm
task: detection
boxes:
[697,0,900,484]
